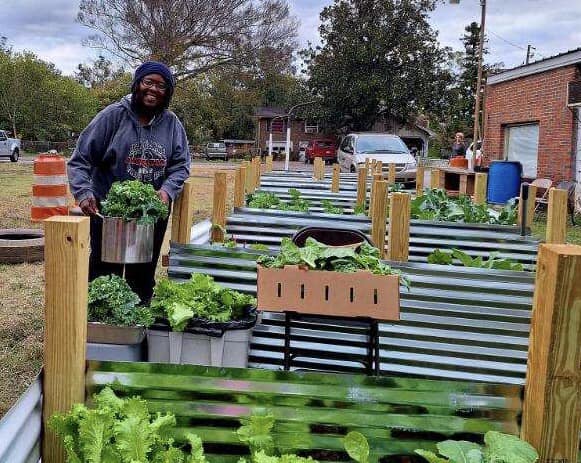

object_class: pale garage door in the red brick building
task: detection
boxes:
[504,124,539,178]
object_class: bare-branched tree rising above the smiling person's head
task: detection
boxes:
[78,0,297,78]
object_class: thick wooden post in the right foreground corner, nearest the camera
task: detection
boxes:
[521,245,581,463]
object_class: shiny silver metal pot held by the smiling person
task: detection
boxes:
[101,217,154,264]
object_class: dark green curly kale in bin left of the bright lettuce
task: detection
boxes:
[88,275,153,327]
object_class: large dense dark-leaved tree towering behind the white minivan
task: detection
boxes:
[302,0,451,130]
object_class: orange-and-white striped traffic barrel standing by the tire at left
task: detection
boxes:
[30,153,69,222]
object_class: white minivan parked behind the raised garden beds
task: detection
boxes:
[337,132,417,183]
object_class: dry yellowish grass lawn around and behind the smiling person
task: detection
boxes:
[0,162,234,417]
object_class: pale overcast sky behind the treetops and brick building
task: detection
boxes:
[0,0,581,74]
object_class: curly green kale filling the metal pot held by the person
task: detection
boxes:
[101,180,169,224]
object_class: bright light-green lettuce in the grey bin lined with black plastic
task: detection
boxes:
[150,273,256,331]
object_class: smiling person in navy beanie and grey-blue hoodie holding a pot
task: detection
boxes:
[68,61,190,304]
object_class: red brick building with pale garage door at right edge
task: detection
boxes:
[483,48,581,183]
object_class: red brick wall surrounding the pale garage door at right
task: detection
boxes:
[483,66,579,182]
